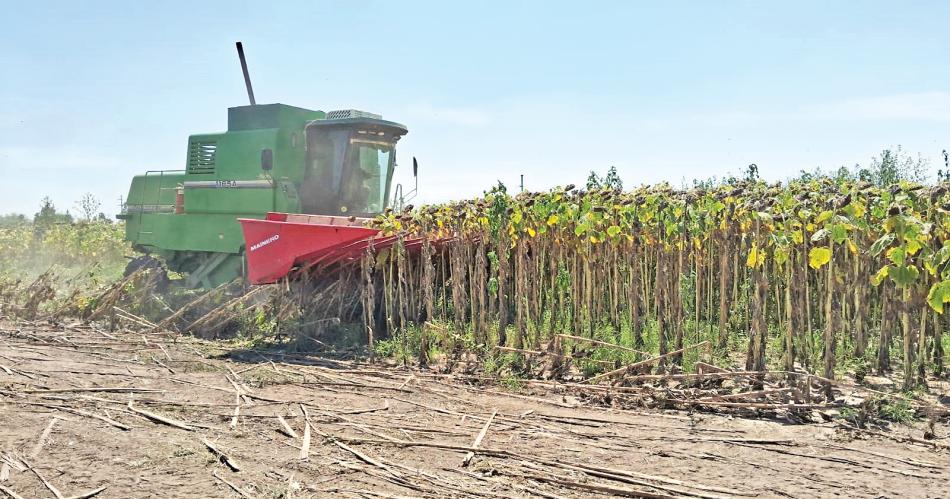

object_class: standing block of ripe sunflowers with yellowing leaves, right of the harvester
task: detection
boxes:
[363,178,950,382]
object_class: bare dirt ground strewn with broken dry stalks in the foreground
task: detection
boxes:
[0,321,950,498]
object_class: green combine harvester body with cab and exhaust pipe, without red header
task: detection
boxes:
[118,42,417,287]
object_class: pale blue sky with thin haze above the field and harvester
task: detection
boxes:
[0,1,950,214]
